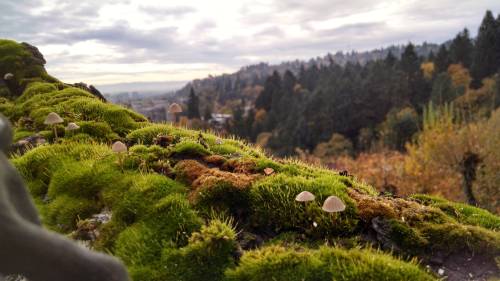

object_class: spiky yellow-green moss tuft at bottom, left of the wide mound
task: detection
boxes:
[162,220,237,281]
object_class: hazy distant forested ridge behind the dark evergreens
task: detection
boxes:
[176,43,439,103]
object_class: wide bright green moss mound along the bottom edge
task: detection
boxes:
[226,246,435,281]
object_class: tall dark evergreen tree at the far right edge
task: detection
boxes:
[471,11,500,87]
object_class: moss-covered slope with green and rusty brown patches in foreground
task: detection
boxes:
[0,40,500,281]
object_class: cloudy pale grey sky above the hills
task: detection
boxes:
[0,0,500,89]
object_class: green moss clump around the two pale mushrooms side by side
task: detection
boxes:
[250,174,358,236]
